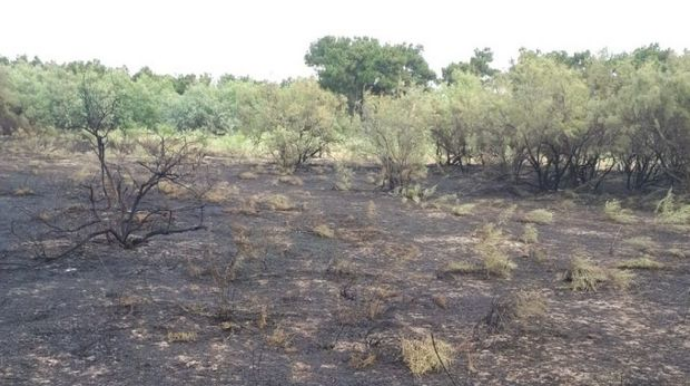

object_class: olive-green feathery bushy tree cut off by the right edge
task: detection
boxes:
[614,55,690,189]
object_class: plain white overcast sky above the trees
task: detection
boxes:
[0,0,690,80]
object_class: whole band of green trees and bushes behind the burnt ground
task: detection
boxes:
[0,36,690,190]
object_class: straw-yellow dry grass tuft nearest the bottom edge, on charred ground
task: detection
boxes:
[400,337,455,376]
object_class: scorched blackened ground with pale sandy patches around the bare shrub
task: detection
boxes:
[0,143,690,386]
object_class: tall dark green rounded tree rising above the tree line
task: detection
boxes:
[305,36,435,113]
